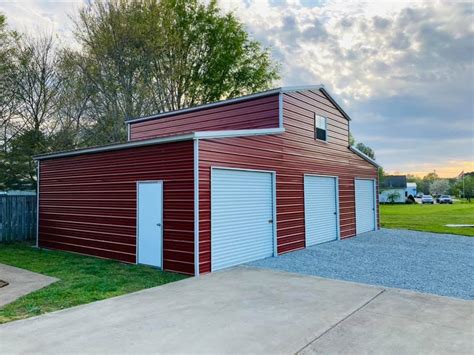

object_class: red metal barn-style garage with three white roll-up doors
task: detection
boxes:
[36,86,378,274]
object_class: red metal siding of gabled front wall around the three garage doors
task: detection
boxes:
[199,91,377,273]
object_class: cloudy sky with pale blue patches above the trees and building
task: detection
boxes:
[0,0,474,177]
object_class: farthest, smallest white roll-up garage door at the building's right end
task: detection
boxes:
[355,179,375,234]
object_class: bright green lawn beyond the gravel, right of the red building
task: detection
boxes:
[380,203,474,237]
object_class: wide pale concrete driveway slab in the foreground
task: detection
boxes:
[0,267,474,355]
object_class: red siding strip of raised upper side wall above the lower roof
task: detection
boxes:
[130,95,278,140]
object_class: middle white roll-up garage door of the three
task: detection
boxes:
[304,175,338,246]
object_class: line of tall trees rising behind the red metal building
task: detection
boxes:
[0,0,278,190]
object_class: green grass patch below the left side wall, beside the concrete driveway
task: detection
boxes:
[0,244,186,323]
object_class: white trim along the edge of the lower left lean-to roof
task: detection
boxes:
[33,128,285,160]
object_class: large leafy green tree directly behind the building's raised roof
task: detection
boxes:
[70,0,278,143]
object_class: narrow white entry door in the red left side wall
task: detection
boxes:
[137,181,163,267]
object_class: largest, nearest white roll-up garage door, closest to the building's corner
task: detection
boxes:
[211,169,274,271]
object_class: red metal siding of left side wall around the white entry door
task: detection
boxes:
[39,141,194,274]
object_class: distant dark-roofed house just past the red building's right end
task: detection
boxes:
[379,175,416,203]
